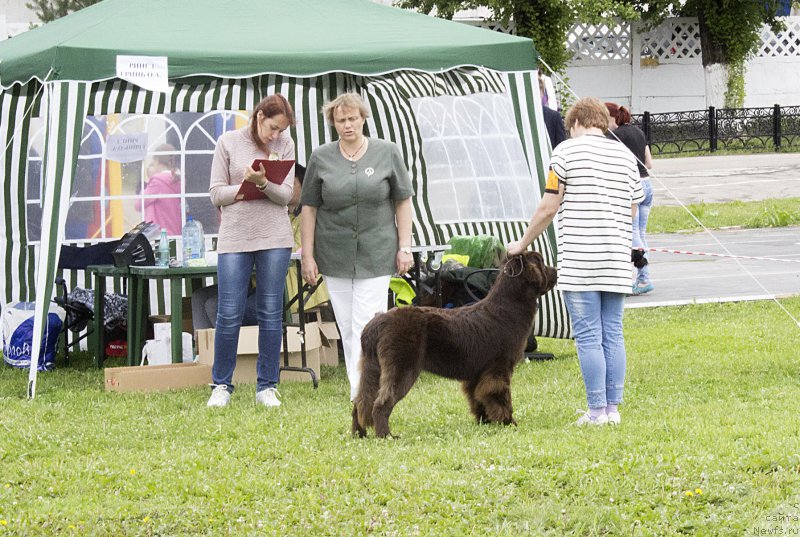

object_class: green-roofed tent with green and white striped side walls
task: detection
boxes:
[0,0,570,396]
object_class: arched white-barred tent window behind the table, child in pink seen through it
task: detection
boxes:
[26,110,248,243]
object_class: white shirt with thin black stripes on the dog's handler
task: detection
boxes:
[546,134,644,293]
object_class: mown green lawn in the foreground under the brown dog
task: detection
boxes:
[0,298,800,536]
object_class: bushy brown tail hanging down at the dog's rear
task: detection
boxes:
[353,315,383,436]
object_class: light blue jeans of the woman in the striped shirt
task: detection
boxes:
[564,291,626,408]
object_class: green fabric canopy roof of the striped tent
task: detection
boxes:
[0,0,536,87]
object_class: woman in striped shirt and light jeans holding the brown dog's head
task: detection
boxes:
[507,97,644,425]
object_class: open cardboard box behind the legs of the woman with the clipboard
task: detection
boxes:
[197,323,322,384]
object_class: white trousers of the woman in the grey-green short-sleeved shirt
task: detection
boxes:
[324,276,391,401]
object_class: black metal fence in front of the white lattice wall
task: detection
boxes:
[632,104,800,155]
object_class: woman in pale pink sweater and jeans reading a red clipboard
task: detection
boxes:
[208,94,295,407]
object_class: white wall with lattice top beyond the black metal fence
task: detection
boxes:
[566,17,800,113]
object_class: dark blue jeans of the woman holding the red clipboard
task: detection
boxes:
[211,248,291,392]
